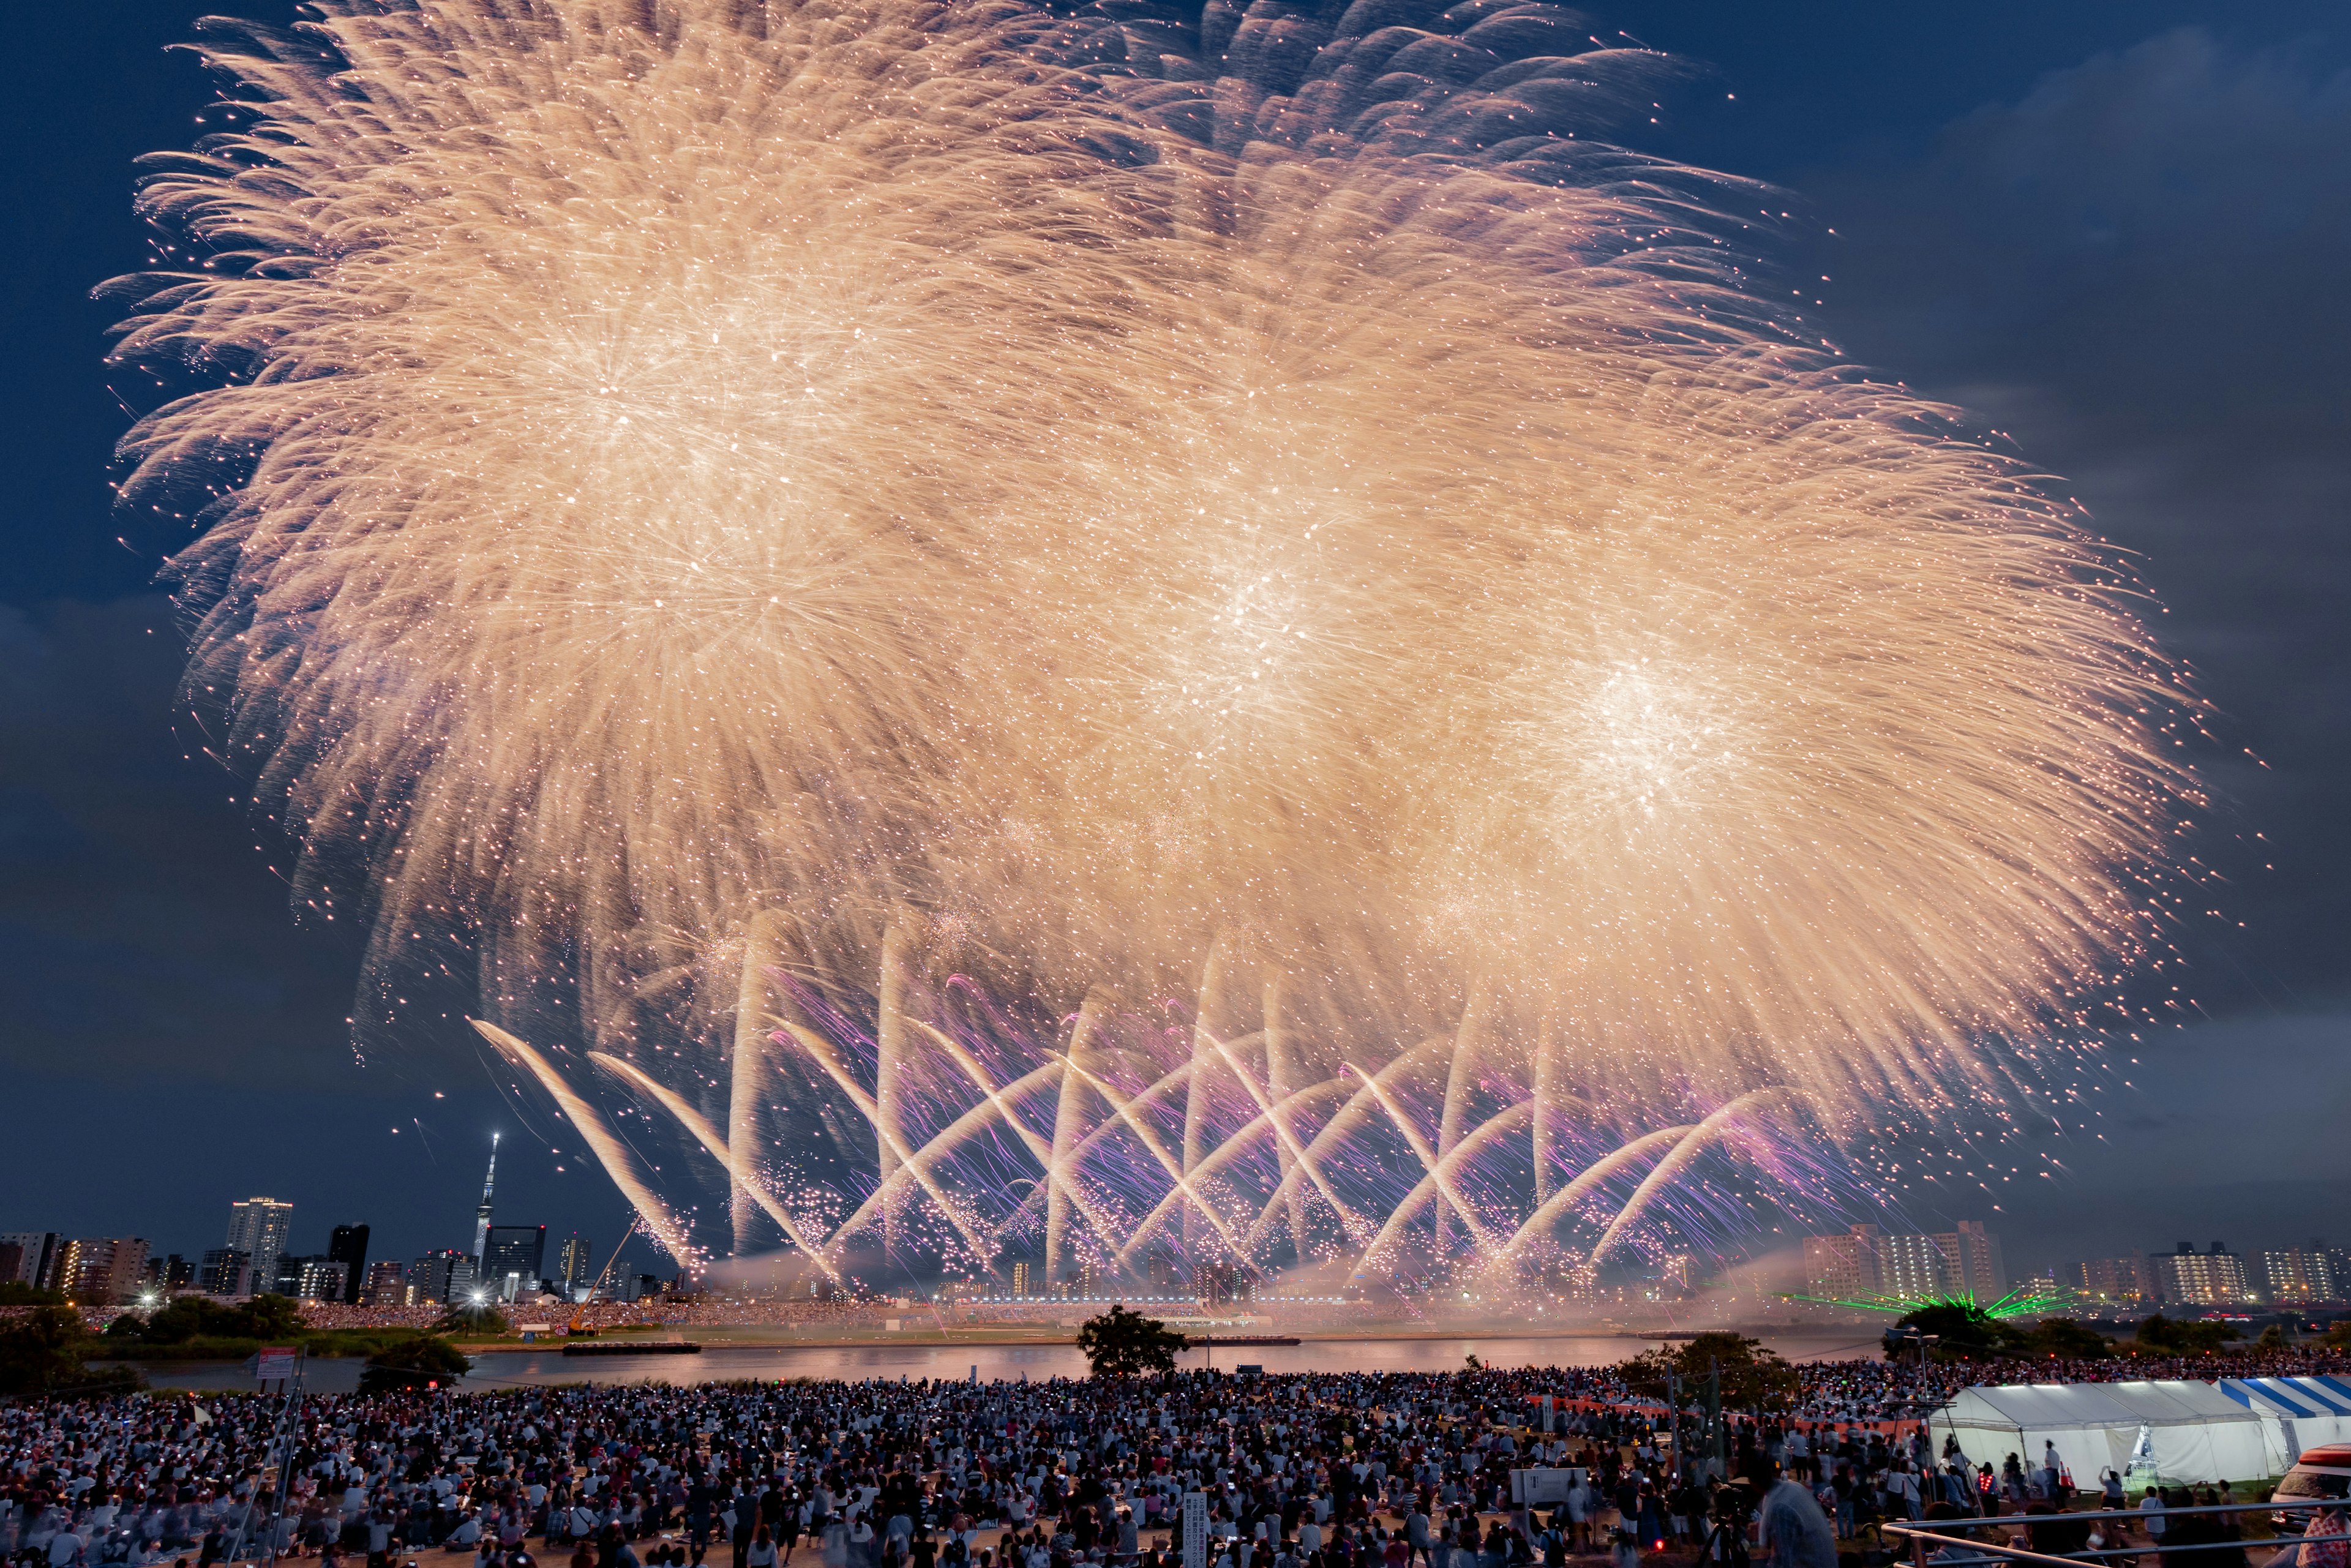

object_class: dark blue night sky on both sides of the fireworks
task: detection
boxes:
[0,0,2351,1269]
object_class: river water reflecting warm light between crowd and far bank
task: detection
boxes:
[141,1328,1878,1392]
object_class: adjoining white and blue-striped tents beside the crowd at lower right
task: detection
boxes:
[1928,1378,2351,1488]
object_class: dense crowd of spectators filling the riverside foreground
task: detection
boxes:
[0,1364,2332,1568]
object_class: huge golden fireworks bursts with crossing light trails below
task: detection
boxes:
[120,0,2194,1262]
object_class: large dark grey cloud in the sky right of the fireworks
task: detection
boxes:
[1801,31,2351,1011]
